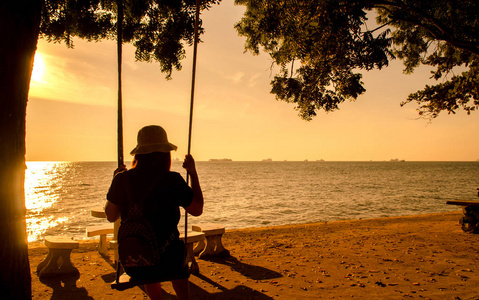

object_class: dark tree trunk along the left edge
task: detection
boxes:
[0,0,43,299]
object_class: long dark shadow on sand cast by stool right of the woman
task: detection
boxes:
[205,255,283,280]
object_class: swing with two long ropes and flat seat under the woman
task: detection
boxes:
[111,0,201,291]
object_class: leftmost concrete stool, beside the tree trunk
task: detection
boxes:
[37,236,79,278]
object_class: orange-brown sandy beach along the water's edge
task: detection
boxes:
[29,211,479,300]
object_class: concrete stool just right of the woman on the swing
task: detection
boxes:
[191,223,229,258]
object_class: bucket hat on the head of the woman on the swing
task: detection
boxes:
[130,125,178,155]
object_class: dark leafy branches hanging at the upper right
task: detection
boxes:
[236,0,479,120]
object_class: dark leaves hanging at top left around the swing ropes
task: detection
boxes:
[40,0,221,78]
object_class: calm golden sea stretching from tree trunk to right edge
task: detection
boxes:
[25,161,479,241]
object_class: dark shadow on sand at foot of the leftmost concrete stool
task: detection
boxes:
[40,274,93,300]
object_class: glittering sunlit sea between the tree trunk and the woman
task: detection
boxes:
[25,162,119,242]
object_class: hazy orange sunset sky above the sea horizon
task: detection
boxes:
[27,0,479,161]
